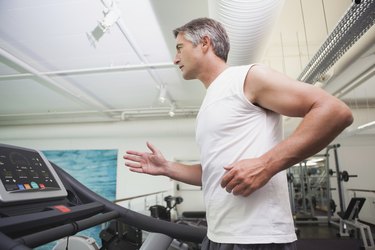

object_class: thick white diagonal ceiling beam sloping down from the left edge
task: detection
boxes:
[0,48,116,117]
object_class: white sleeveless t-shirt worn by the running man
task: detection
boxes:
[196,65,297,244]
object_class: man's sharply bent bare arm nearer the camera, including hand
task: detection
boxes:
[221,65,353,196]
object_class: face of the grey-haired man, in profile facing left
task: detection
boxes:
[174,33,202,80]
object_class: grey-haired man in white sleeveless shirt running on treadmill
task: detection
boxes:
[124,18,353,249]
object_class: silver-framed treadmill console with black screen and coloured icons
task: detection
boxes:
[0,144,67,205]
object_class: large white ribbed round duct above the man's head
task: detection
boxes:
[208,0,285,65]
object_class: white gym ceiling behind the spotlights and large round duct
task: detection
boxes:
[0,0,375,137]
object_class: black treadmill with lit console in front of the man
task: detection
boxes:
[0,144,206,250]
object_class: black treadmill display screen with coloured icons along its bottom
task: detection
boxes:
[0,146,60,192]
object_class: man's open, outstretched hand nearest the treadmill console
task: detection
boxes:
[124,142,168,175]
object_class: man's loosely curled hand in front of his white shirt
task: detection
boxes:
[221,158,272,197]
